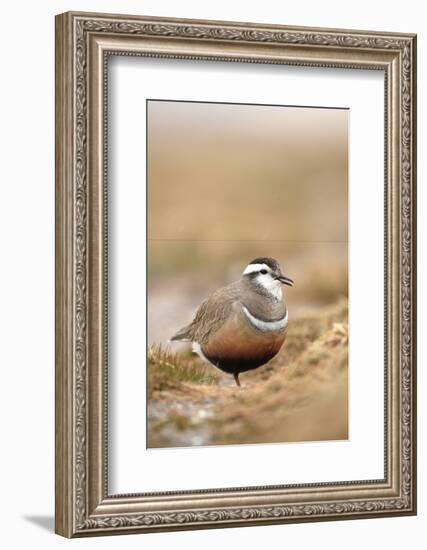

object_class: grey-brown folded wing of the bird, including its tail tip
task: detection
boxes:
[171,283,239,344]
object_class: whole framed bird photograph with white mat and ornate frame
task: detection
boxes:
[56,12,416,537]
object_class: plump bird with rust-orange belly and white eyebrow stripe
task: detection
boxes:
[170,257,294,386]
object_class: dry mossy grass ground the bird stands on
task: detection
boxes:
[149,301,348,447]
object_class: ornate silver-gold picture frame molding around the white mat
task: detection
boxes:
[55,12,416,537]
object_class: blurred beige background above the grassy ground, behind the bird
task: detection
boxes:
[147,100,348,344]
